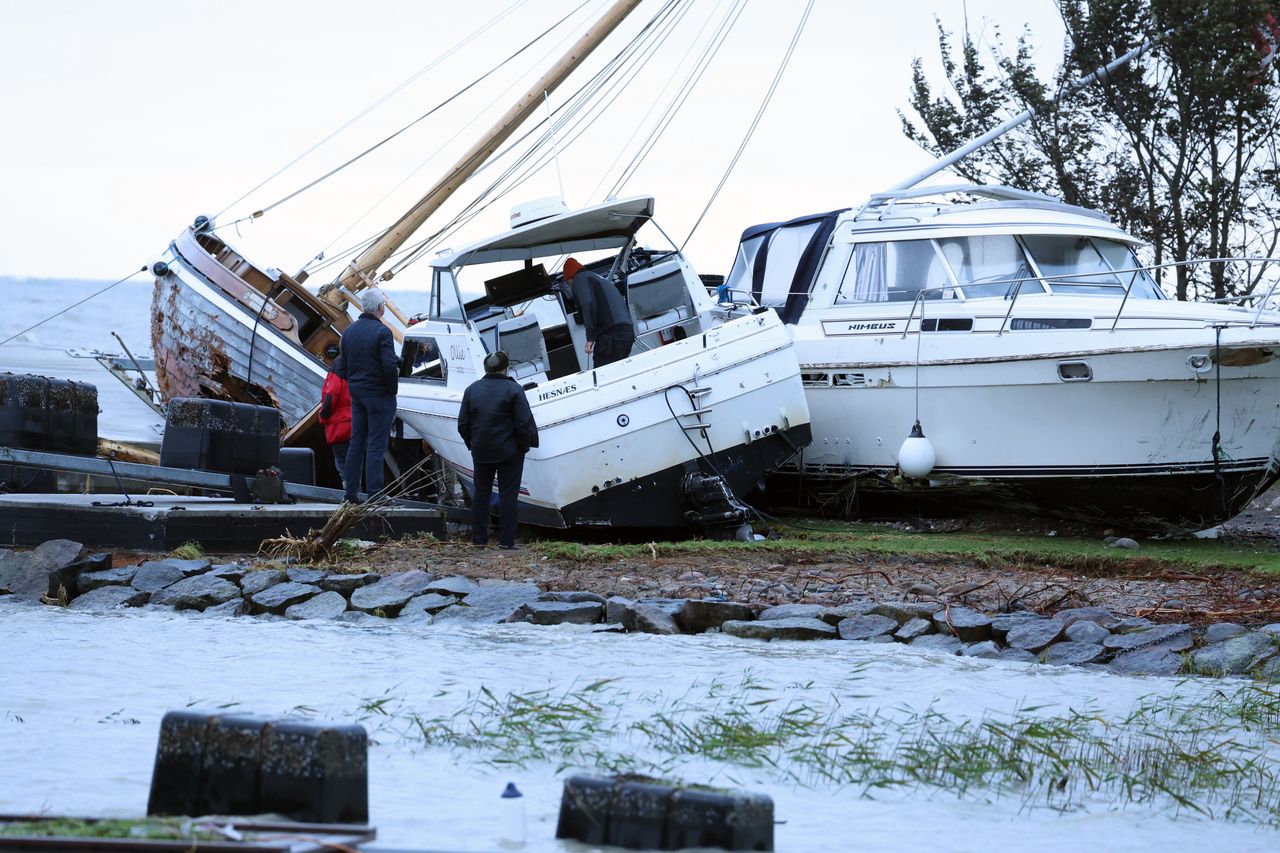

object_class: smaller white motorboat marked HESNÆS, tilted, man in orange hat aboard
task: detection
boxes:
[398,197,810,528]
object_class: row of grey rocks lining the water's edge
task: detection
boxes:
[0,539,1280,681]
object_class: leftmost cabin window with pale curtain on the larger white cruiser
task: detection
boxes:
[836,240,955,304]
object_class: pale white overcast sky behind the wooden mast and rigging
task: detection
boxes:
[0,0,1062,288]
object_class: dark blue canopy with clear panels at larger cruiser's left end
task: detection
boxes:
[726,207,849,323]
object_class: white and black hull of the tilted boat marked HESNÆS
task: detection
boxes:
[398,311,809,528]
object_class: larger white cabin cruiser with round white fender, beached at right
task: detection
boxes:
[722,186,1280,530]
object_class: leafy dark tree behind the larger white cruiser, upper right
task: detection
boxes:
[900,0,1280,298]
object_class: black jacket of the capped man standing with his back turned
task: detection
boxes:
[458,373,538,464]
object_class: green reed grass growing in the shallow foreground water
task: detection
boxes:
[365,679,1280,826]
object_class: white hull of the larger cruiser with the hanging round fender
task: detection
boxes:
[796,298,1280,528]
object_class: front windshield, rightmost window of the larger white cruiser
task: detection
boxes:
[1023,234,1164,300]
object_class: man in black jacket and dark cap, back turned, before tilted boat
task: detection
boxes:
[458,350,538,551]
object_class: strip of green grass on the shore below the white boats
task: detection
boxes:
[524,521,1280,575]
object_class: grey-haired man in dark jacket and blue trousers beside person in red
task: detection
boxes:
[342,287,399,503]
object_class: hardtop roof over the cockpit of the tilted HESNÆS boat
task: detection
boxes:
[431,196,654,269]
